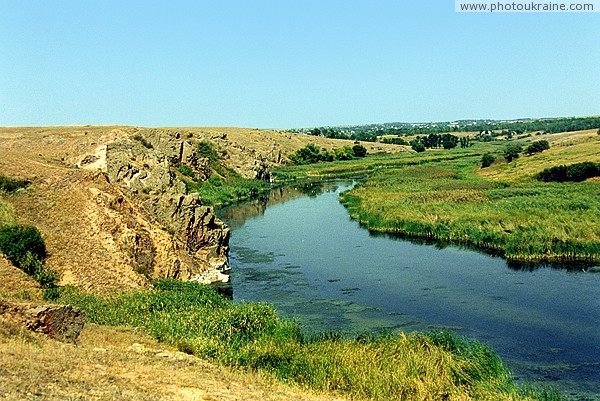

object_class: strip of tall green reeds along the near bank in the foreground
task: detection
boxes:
[57,280,554,400]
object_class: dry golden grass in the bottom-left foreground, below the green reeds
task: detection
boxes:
[0,322,346,401]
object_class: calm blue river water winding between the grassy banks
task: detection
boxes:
[221,182,600,400]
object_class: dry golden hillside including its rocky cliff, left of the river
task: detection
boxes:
[0,126,400,291]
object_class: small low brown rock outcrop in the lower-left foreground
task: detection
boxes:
[0,300,85,342]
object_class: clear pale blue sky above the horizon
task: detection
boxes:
[0,0,600,128]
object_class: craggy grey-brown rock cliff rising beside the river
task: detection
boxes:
[101,130,229,283]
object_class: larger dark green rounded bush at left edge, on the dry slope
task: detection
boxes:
[0,225,46,268]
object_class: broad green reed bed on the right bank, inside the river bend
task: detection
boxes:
[342,160,600,260]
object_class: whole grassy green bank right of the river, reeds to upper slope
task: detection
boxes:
[280,131,600,263]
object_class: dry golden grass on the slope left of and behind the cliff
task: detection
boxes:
[0,126,398,291]
